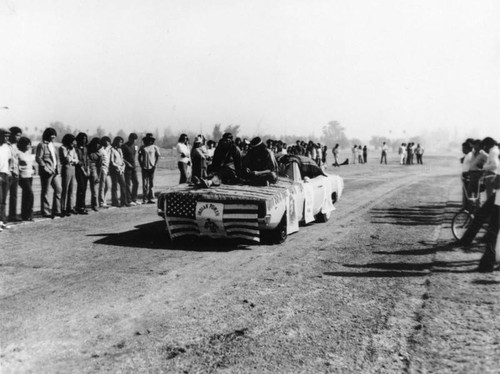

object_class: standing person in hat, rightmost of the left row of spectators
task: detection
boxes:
[139,133,160,204]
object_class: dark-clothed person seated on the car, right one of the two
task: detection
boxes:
[243,137,278,186]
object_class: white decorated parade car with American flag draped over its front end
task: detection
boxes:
[158,155,344,243]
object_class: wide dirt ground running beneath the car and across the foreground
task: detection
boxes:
[0,157,500,373]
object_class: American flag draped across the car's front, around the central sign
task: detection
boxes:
[164,193,260,242]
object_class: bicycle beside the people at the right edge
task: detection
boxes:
[451,175,494,240]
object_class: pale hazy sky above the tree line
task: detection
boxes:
[0,0,500,139]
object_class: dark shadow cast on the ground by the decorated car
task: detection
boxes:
[89,220,255,252]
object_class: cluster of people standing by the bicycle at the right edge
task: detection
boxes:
[454,137,500,272]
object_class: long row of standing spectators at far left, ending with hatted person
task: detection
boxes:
[0,127,160,231]
